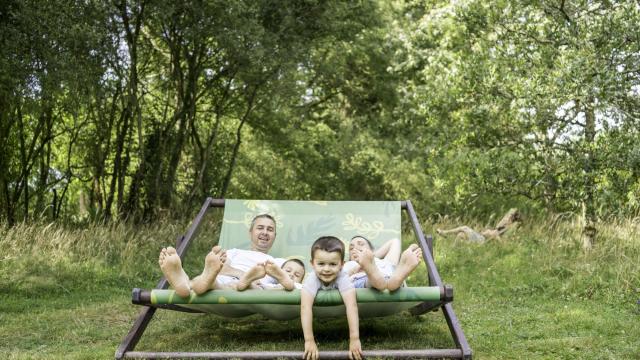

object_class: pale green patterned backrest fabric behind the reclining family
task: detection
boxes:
[219,199,401,265]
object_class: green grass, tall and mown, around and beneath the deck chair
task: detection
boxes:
[0,215,640,359]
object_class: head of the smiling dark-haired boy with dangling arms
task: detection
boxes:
[311,236,344,285]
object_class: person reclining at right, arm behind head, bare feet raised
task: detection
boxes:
[344,235,422,291]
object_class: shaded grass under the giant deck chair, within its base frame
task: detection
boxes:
[136,310,455,351]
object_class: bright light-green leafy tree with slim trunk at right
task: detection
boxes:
[388,1,640,247]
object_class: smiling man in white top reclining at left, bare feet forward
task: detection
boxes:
[158,214,295,297]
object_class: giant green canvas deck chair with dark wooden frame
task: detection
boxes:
[115,198,471,359]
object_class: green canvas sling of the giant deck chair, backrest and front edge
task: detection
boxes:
[152,199,432,320]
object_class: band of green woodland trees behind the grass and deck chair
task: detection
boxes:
[0,0,640,235]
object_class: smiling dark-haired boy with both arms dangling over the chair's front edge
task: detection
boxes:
[300,236,363,360]
